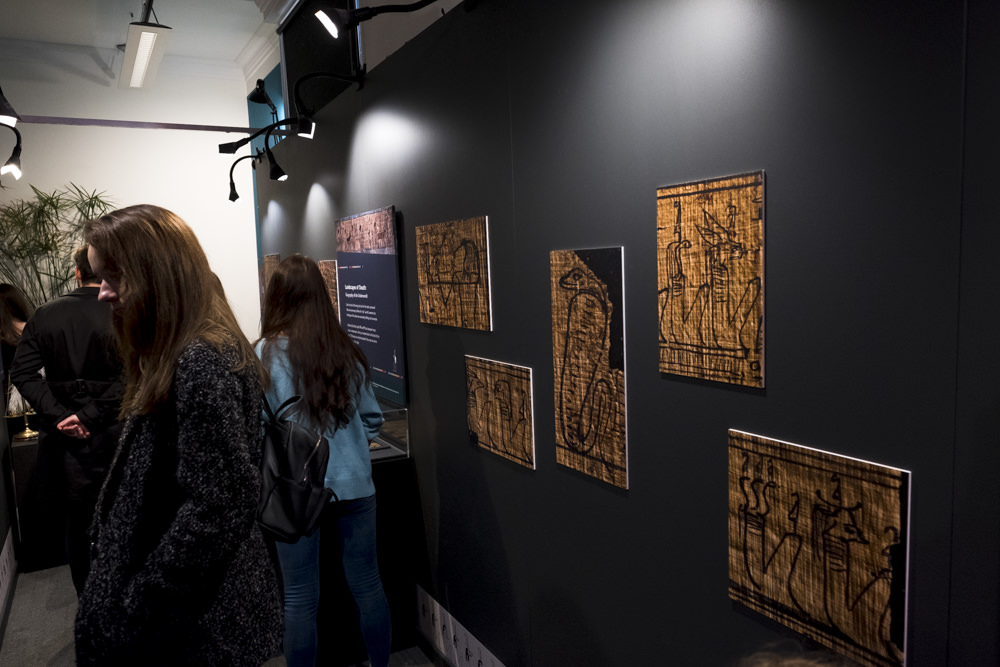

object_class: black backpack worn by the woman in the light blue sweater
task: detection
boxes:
[257,396,337,542]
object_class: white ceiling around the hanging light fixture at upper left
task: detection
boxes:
[0,0,273,62]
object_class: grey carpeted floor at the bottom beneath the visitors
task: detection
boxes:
[0,565,434,667]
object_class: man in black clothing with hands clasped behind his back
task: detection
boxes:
[11,247,123,595]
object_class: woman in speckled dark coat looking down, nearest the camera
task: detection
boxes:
[76,205,281,666]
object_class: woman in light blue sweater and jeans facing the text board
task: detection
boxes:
[257,255,391,667]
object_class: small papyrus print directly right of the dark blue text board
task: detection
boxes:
[417,216,493,331]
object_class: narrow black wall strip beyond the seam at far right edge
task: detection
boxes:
[949,1,1000,665]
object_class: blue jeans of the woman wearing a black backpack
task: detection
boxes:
[275,495,392,667]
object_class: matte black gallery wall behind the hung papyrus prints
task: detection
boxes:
[258,0,1000,667]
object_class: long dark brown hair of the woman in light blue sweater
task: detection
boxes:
[260,255,369,429]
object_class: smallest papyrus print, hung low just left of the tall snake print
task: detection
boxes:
[465,356,535,470]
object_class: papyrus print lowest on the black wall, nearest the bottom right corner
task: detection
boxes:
[729,430,910,666]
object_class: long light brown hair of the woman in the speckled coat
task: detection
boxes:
[83,204,263,416]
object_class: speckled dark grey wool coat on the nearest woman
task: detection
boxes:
[76,341,282,667]
